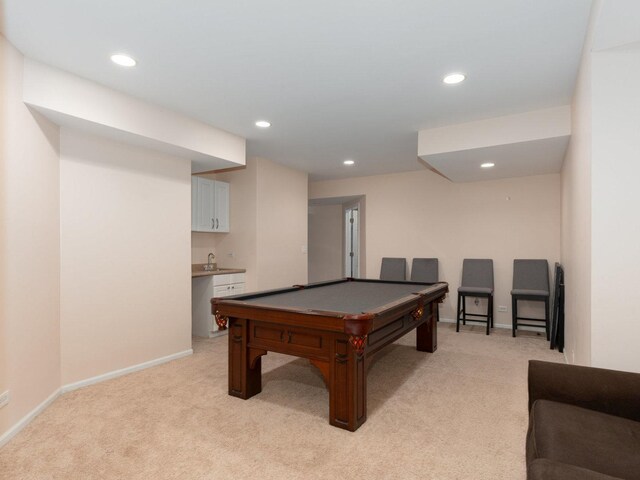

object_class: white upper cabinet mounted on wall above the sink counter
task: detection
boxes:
[191,176,229,232]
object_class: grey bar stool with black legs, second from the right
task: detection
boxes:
[456,258,493,335]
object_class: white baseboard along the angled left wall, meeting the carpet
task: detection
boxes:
[0,349,193,448]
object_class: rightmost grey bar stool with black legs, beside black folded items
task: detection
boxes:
[511,260,550,340]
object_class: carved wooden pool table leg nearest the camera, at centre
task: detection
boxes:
[329,336,367,432]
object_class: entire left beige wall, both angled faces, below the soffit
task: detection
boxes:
[0,32,216,443]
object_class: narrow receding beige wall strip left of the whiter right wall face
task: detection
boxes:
[562,7,595,365]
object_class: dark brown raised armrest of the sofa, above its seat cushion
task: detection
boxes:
[529,360,640,421]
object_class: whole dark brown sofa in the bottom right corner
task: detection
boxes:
[527,360,640,480]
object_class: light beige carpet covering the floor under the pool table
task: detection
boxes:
[0,323,564,480]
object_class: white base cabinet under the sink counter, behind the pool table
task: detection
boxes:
[191,273,245,337]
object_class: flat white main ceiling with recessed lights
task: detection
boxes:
[3,0,591,179]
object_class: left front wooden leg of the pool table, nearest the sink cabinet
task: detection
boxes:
[229,318,267,400]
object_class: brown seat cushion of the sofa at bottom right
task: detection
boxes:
[527,400,640,480]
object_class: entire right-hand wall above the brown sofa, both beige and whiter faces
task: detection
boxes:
[562,1,640,371]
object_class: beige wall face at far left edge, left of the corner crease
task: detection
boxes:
[0,35,60,437]
